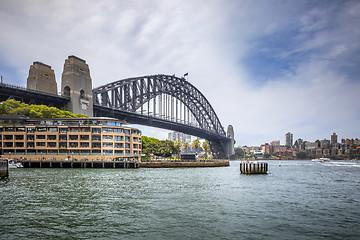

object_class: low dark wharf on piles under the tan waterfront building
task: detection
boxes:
[20,160,140,168]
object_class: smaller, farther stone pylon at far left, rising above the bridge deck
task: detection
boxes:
[27,62,57,94]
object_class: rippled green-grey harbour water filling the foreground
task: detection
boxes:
[0,161,360,239]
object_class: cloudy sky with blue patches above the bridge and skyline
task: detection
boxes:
[0,0,360,146]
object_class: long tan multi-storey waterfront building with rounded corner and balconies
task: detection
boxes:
[0,117,141,159]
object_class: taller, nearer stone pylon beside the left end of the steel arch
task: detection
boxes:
[61,56,93,117]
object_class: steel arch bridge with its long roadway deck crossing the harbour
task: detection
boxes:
[0,57,234,158]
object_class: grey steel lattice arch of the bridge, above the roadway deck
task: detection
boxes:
[93,75,226,137]
